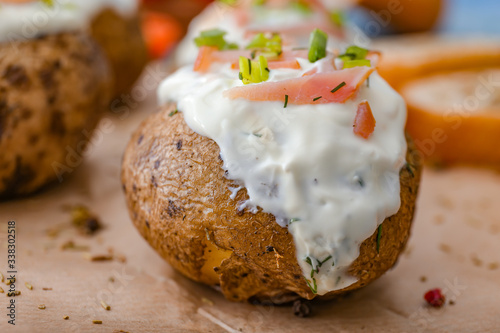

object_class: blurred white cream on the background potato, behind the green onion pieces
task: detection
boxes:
[175,1,353,66]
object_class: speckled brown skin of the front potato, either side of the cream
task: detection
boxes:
[122,107,421,303]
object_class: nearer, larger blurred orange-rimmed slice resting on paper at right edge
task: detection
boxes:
[399,66,500,167]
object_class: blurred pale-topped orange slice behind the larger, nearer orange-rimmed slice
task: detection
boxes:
[372,34,500,89]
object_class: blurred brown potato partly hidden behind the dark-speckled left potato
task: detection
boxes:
[90,9,148,97]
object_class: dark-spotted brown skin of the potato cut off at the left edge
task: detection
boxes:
[0,33,112,198]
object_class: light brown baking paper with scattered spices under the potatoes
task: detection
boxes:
[0,65,500,333]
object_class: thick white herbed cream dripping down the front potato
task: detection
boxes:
[158,55,407,295]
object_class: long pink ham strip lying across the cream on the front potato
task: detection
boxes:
[223,66,375,104]
